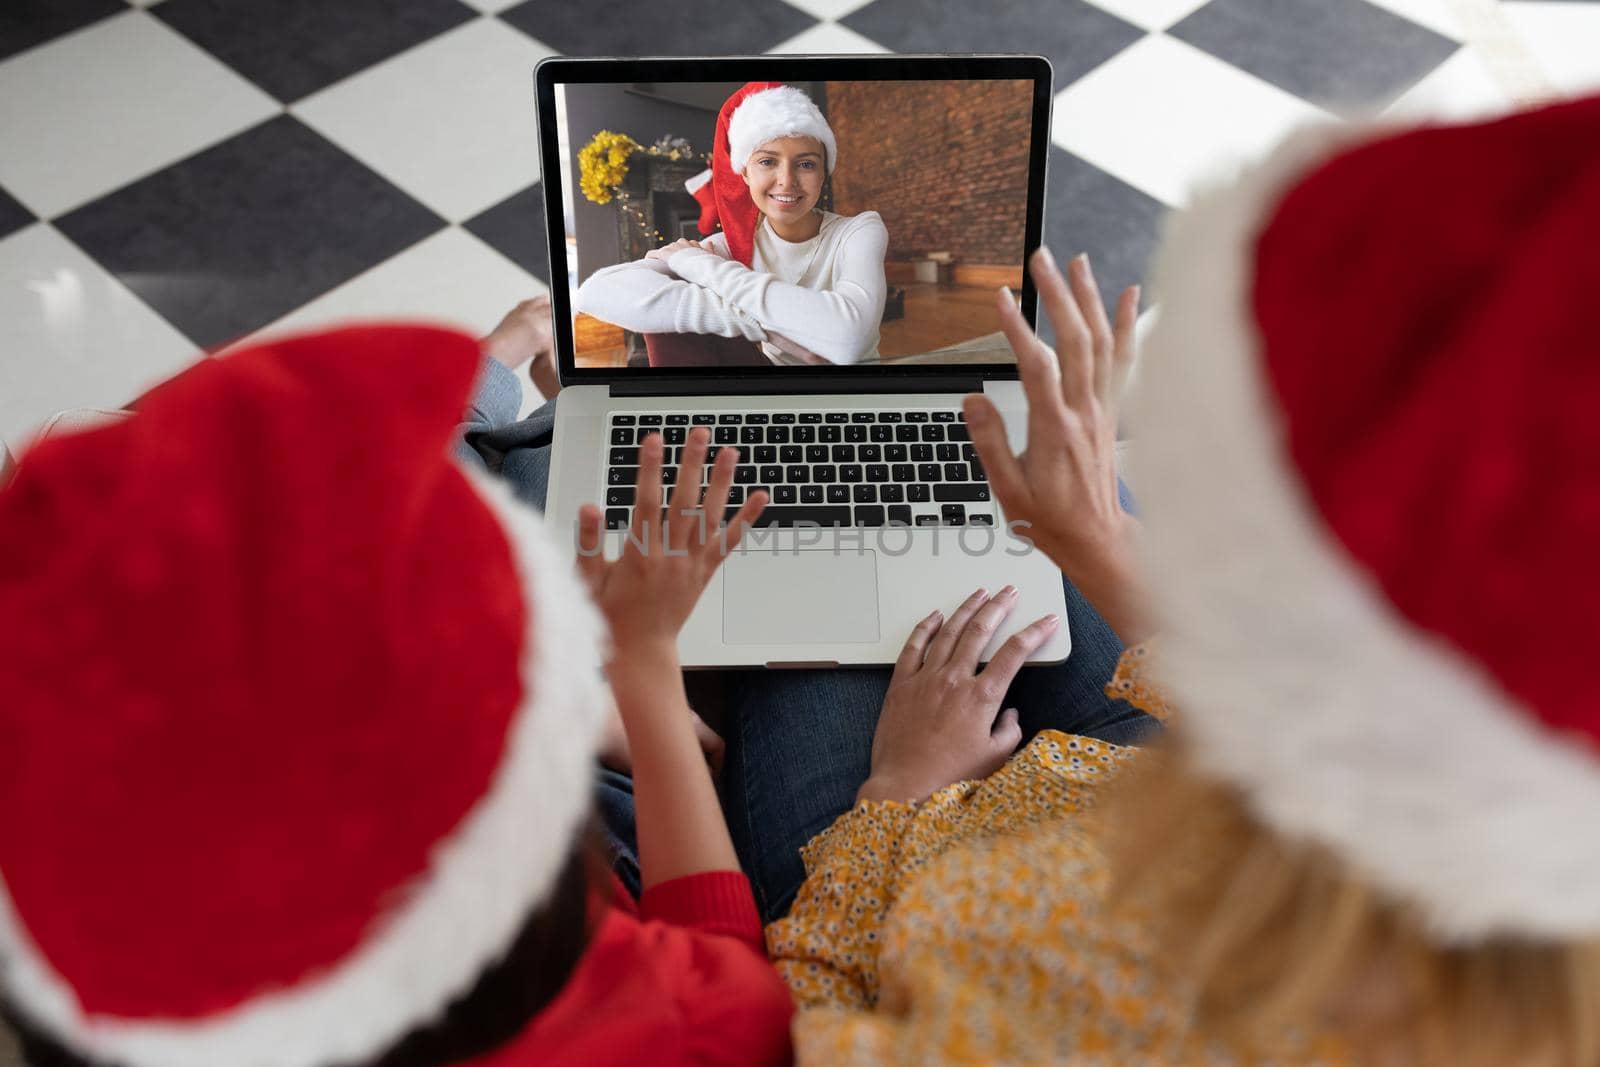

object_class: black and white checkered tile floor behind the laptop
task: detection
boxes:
[0,0,1600,446]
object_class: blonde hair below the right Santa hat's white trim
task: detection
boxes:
[1106,739,1600,1067]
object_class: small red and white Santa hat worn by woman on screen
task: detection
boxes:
[683,82,838,267]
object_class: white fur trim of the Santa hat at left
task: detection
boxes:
[0,470,611,1067]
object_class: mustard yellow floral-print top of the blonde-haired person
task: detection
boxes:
[766,646,1344,1067]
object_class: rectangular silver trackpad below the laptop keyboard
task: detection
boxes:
[722,549,878,645]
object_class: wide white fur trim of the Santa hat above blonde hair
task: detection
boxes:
[1128,120,1600,944]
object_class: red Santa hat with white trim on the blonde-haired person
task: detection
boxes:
[1130,91,1600,944]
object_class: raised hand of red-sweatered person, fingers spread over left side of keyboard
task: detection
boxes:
[578,426,766,659]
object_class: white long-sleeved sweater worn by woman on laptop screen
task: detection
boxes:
[576,211,888,363]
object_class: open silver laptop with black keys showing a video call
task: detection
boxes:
[534,56,1072,667]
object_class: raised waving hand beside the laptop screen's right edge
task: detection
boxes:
[965,248,1144,643]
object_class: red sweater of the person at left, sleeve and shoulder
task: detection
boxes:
[472,870,792,1067]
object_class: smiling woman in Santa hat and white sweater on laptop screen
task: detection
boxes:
[576,82,888,366]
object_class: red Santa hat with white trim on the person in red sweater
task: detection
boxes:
[0,328,608,1067]
